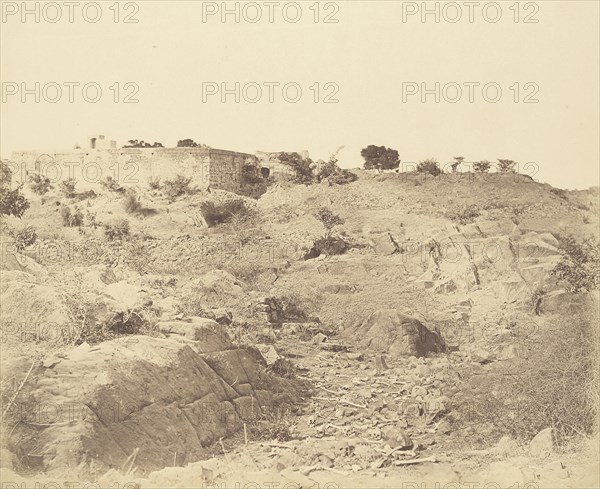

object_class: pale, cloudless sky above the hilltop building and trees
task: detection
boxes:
[0,0,600,188]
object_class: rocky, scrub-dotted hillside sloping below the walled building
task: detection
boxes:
[0,171,600,487]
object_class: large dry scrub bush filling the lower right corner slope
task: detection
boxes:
[454,312,599,442]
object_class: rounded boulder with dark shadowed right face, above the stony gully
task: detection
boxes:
[356,309,445,356]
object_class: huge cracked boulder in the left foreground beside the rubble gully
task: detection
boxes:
[7,330,298,475]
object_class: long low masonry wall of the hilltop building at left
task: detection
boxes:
[6,148,256,192]
